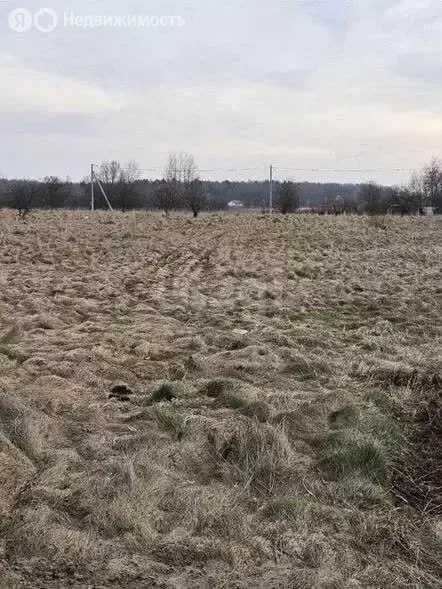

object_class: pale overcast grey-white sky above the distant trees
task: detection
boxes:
[0,0,442,183]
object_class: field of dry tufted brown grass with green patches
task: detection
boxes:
[0,212,442,589]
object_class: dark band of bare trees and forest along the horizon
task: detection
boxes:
[0,153,442,217]
